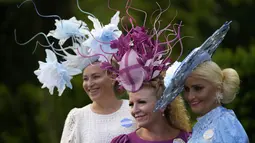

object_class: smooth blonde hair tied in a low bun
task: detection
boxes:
[192,61,240,104]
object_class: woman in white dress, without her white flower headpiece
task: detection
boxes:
[61,62,136,143]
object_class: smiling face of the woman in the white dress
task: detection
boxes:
[83,63,114,101]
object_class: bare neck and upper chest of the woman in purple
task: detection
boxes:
[136,119,180,141]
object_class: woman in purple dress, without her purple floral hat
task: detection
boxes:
[111,77,191,143]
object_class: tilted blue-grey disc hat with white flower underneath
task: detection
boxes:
[155,22,231,110]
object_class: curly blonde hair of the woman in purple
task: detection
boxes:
[143,76,191,132]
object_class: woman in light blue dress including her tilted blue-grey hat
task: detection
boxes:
[151,22,248,143]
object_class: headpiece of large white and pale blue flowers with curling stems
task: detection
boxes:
[15,1,122,96]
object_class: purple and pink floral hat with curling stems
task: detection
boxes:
[102,4,182,92]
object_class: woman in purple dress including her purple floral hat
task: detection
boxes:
[98,2,191,143]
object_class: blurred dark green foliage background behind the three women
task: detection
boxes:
[0,0,255,143]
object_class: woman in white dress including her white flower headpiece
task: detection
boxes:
[22,8,136,143]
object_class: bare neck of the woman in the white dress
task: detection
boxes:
[91,95,122,114]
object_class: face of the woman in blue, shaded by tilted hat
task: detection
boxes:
[184,74,219,116]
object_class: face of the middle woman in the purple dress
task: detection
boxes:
[129,87,161,128]
